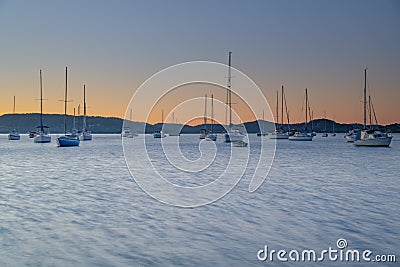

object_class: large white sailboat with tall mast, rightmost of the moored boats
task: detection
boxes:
[354,69,392,146]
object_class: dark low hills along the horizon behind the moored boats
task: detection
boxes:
[0,113,400,134]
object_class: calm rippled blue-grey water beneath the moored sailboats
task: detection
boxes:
[0,134,400,266]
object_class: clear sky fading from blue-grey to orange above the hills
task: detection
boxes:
[0,0,400,124]
